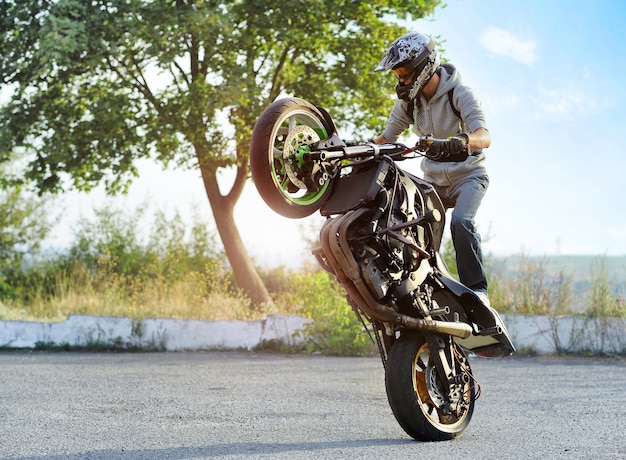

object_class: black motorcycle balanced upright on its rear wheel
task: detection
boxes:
[250,97,515,441]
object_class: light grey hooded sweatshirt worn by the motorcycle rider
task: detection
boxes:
[383,64,487,186]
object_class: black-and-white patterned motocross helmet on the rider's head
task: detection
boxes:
[374,32,440,101]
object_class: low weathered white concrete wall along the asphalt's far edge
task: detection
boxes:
[0,315,626,354]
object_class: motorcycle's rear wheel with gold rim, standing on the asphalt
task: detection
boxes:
[385,333,476,441]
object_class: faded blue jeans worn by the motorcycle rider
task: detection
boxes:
[434,176,489,293]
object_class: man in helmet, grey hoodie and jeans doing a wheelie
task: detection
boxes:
[374,33,491,306]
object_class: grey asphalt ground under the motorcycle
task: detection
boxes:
[0,352,626,460]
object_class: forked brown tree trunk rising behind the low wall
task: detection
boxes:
[200,162,272,308]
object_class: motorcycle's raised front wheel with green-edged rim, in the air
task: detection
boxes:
[250,98,333,218]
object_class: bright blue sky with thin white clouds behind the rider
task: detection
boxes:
[50,0,626,266]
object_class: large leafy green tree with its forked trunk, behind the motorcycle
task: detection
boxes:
[0,0,439,304]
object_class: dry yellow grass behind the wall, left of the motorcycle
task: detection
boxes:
[0,262,302,321]
